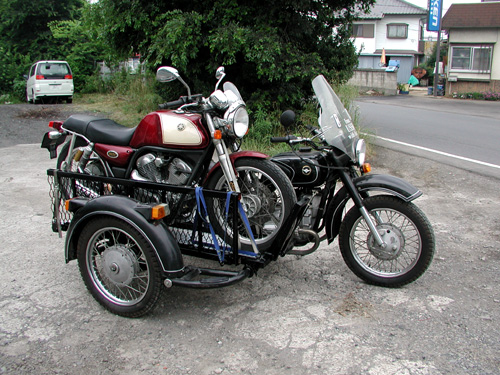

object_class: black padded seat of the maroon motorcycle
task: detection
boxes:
[63,115,136,146]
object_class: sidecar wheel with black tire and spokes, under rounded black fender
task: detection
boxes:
[77,216,162,318]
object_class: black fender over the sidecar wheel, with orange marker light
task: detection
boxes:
[65,195,184,274]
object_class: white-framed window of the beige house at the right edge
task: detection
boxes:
[451,46,492,72]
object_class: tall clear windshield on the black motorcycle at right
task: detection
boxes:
[312,75,359,159]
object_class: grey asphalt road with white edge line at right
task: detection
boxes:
[356,95,500,177]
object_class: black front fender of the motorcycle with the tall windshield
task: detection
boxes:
[325,174,422,243]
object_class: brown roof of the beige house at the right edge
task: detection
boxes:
[442,2,500,30]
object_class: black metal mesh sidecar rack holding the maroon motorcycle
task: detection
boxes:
[47,169,254,265]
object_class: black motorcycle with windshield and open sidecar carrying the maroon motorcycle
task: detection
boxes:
[44,68,434,317]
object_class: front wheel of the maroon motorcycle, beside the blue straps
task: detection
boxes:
[206,158,297,252]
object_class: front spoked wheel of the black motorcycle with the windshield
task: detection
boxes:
[339,195,435,287]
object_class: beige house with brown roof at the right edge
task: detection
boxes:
[442,2,500,94]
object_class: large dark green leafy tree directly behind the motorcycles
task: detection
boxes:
[87,0,374,106]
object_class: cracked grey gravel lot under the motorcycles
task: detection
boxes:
[0,105,500,375]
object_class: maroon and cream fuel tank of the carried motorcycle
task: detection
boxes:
[130,111,210,150]
